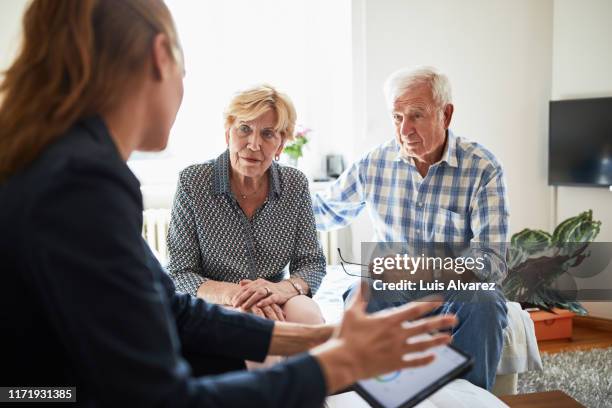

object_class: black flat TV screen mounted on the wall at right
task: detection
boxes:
[548,98,612,187]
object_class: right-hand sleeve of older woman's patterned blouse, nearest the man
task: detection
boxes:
[289,180,326,295]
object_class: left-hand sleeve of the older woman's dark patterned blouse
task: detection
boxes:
[167,173,206,296]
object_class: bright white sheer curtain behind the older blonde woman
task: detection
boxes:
[130,0,352,191]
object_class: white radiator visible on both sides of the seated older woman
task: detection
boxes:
[142,208,338,265]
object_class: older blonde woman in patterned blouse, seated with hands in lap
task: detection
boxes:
[168,85,325,323]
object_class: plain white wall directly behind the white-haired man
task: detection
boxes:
[352,0,552,258]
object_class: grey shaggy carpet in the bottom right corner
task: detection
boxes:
[518,347,612,408]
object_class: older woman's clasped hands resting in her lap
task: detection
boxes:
[229,278,298,322]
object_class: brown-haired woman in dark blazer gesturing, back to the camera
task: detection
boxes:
[0,0,453,407]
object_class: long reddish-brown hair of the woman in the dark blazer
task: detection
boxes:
[0,0,182,182]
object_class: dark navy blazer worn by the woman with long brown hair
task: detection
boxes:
[0,117,325,407]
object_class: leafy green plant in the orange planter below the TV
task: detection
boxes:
[503,210,601,315]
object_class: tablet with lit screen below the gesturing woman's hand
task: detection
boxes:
[353,345,473,408]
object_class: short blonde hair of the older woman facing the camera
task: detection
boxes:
[223,84,297,140]
